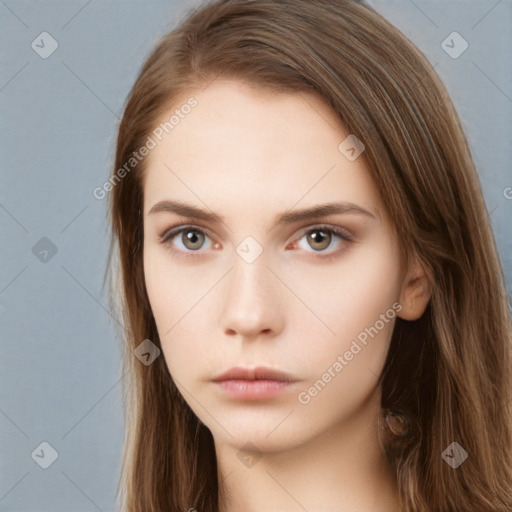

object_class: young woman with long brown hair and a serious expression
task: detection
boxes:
[110,0,512,512]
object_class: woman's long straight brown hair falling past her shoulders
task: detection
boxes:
[105,0,512,512]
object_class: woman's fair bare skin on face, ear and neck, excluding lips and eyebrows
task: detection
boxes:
[144,81,429,512]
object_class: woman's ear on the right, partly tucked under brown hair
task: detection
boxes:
[398,259,431,320]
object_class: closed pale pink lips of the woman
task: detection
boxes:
[213,366,297,400]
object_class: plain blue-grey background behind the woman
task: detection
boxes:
[0,0,512,512]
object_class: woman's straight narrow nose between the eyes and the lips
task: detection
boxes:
[220,255,285,340]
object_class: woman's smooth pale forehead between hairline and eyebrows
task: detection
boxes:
[144,81,377,221]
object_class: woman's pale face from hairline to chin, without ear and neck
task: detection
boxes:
[143,81,410,451]
